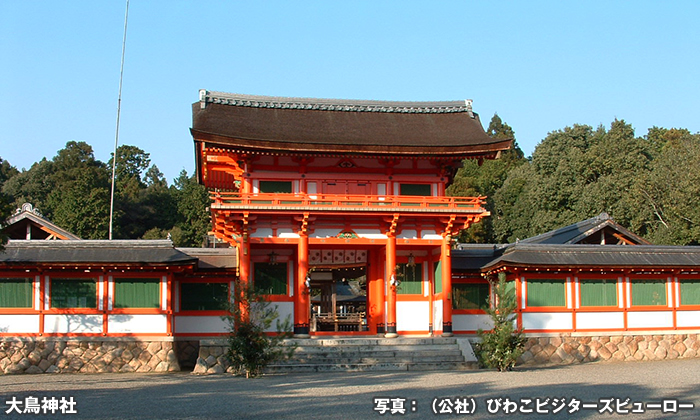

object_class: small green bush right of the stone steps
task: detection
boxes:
[476,276,526,372]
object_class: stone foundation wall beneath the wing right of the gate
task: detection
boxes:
[519,334,700,365]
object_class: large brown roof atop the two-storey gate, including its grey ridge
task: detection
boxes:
[192,91,512,157]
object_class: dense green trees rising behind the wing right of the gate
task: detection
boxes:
[448,115,700,245]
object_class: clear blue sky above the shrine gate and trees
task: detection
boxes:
[0,0,700,182]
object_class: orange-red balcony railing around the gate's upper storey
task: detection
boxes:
[211,192,486,213]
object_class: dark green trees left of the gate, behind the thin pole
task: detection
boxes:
[0,141,210,246]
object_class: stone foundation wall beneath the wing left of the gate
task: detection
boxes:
[0,338,183,374]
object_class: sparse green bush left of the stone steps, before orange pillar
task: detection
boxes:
[223,281,295,378]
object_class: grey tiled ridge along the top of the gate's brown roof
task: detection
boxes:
[199,89,473,116]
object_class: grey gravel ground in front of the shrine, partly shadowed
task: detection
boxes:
[0,359,700,420]
